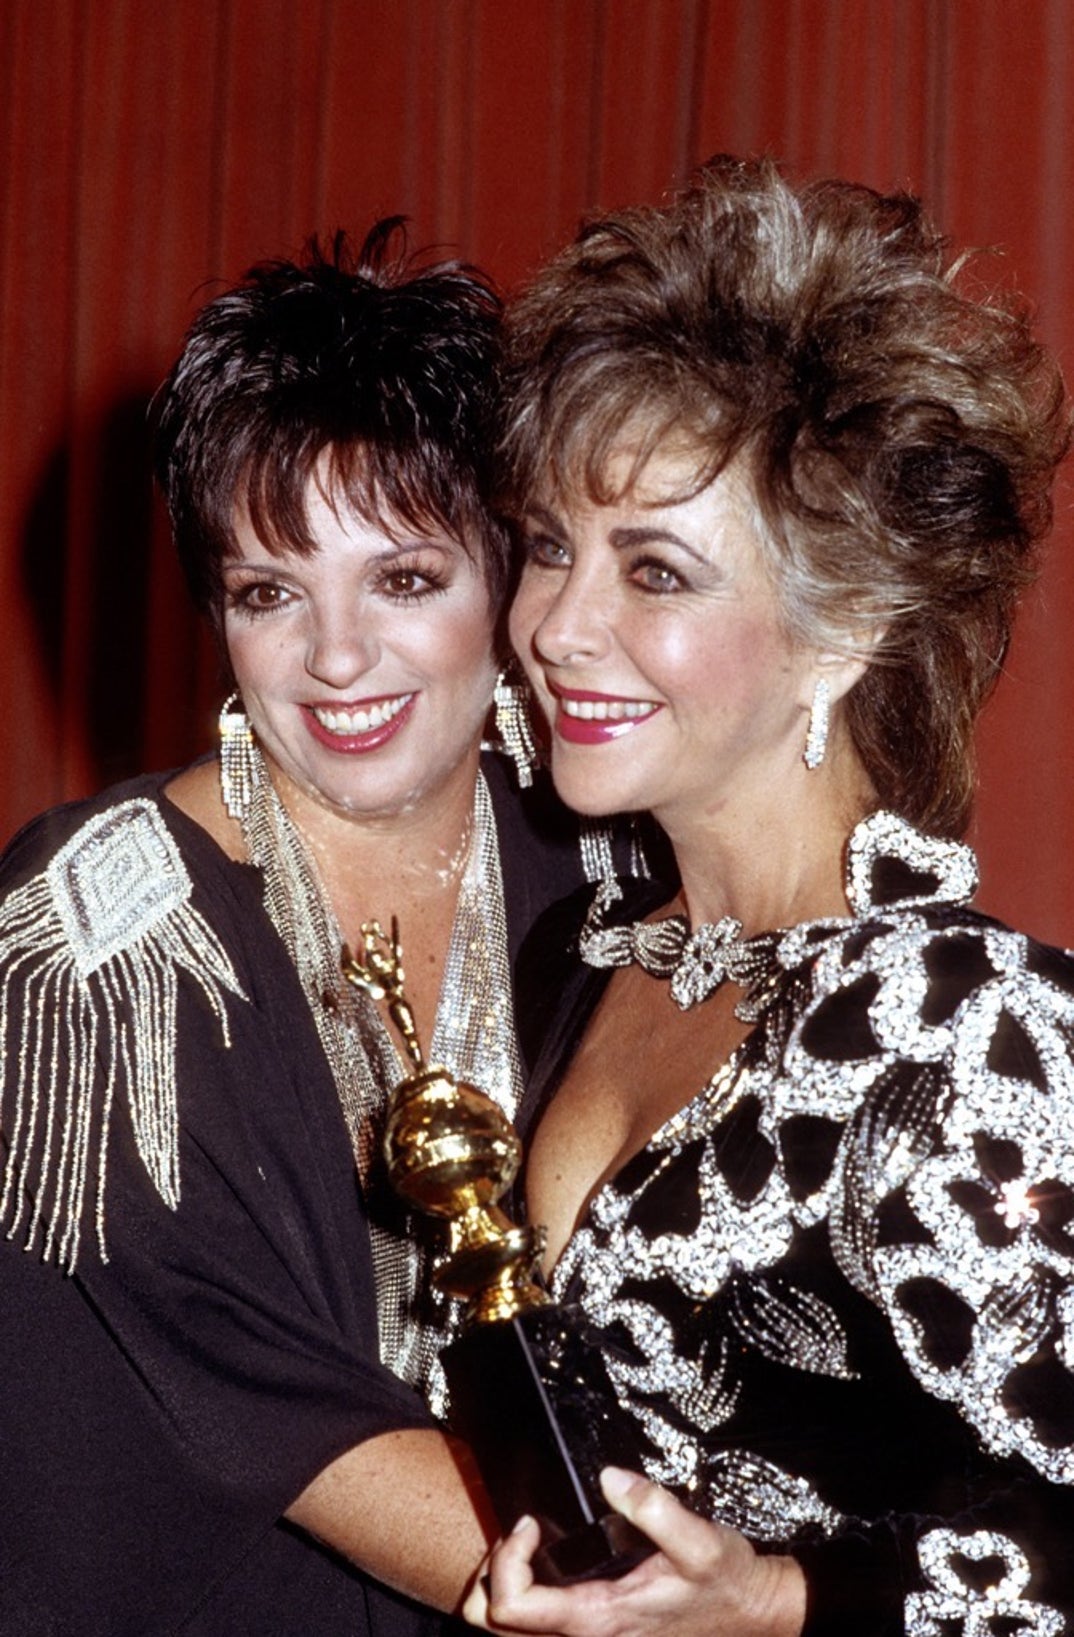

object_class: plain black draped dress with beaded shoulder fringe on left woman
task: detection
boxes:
[0,766,580,1637]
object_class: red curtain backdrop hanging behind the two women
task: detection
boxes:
[0,0,1074,943]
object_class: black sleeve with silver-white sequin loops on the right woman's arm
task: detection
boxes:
[787,912,1074,1637]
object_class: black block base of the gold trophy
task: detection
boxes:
[442,1305,655,1586]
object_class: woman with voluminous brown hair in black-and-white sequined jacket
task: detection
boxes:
[470,159,1074,1637]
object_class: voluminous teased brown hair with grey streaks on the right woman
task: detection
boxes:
[501,157,1069,835]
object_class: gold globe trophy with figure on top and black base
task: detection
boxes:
[342,920,653,1585]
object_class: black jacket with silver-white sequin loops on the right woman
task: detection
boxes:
[517,814,1074,1637]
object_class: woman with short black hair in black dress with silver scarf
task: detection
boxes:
[0,223,602,1637]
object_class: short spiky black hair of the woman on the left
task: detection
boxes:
[156,216,508,622]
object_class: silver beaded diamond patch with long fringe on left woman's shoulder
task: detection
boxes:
[0,762,255,1269]
